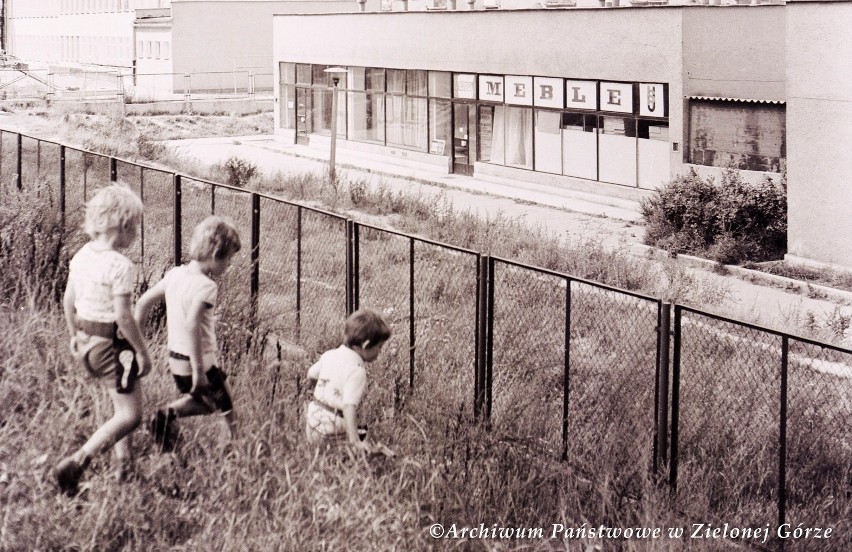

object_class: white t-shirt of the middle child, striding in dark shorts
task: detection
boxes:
[161,265,219,369]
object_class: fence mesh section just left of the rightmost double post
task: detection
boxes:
[567,281,660,493]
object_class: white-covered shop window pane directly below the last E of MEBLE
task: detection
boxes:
[598,115,636,186]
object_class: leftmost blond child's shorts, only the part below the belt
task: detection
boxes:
[77,332,139,393]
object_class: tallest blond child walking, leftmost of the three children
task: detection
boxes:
[55,184,151,495]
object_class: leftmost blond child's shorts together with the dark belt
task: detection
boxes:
[71,320,139,393]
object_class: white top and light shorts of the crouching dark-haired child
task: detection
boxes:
[307,345,367,435]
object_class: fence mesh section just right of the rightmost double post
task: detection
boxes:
[675,311,781,525]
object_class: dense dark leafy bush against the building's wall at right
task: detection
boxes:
[641,170,787,264]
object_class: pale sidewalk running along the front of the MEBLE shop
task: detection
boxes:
[167,136,852,347]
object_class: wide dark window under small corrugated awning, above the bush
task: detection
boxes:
[688,101,786,172]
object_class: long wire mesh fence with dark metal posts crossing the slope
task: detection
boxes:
[0,131,852,546]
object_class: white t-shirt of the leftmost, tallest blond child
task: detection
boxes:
[68,242,136,322]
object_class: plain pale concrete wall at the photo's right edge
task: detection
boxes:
[786,1,852,268]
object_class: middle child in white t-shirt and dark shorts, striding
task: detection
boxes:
[136,216,241,451]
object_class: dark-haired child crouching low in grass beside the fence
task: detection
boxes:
[305,309,391,451]
